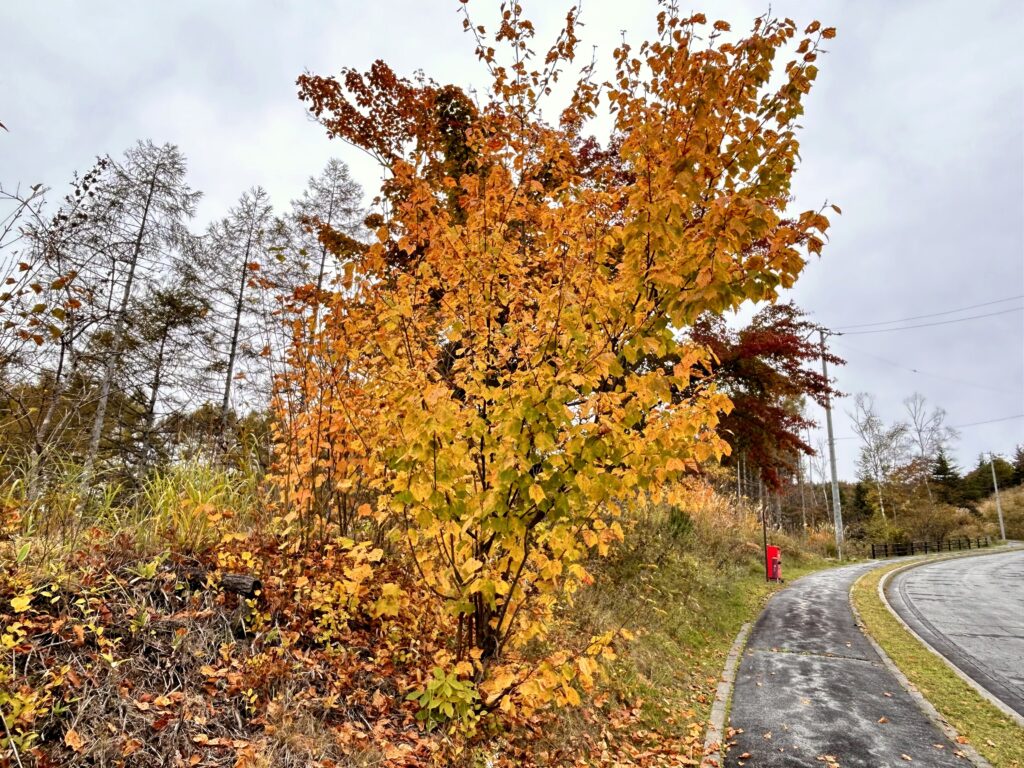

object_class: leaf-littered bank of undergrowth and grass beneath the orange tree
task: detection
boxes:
[0,463,825,766]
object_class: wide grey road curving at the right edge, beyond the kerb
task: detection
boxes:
[886,550,1024,716]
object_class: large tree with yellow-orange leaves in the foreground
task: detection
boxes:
[275,2,835,706]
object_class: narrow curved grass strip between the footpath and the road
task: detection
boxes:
[852,563,1024,768]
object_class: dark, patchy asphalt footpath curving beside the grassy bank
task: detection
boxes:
[725,563,970,768]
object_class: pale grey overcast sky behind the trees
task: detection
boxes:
[0,0,1024,477]
